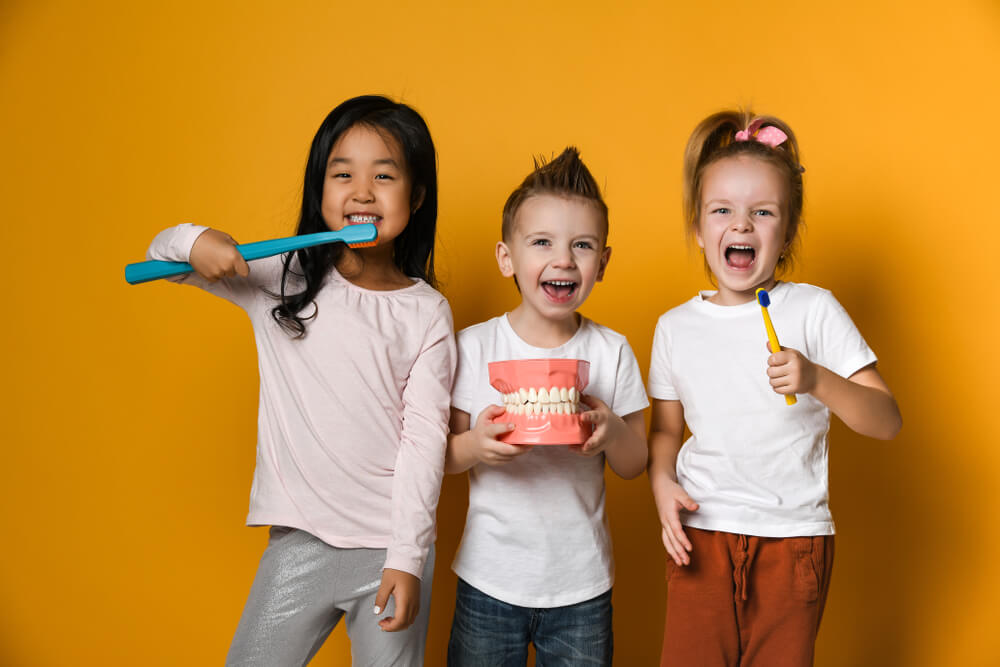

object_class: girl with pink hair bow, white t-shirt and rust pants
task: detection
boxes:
[649,111,902,667]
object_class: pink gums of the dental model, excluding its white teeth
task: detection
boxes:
[489,359,593,445]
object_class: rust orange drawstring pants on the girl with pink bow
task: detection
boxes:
[660,527,833,667]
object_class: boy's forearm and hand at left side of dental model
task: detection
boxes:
[444,405,531,475]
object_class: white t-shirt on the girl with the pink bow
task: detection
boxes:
[649,283,875,537]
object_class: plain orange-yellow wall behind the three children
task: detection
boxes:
[0,0,1000,667]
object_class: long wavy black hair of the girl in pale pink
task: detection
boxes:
[271,95,437,337]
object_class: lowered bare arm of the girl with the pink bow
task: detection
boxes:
[649,399,698,565]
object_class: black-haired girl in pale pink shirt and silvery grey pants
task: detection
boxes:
[147,96,455,665]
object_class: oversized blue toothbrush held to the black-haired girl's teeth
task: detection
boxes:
[125,222,378,285]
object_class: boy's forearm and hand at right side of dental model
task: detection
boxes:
[570,396,648,479]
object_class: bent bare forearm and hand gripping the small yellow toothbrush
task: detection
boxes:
[767,344,903,440]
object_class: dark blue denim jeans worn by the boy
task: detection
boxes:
[448,579,613,667]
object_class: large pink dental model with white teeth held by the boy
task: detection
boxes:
[489,359,593,445]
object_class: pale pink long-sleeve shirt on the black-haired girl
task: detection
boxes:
[147,225,455,577]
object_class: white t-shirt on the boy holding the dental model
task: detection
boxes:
[452,315,649,607]
